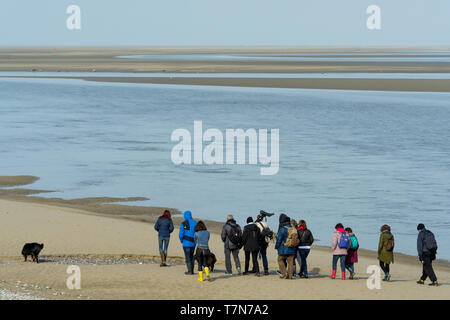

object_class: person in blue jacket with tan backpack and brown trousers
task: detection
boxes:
[275,214,298,279]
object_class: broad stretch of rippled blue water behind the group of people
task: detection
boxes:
[0,79,450,259]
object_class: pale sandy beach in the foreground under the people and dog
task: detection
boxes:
[0,177,450,300]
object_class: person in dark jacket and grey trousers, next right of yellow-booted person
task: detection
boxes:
[221,214,242,275]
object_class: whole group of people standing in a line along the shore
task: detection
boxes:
[155,210,438,286]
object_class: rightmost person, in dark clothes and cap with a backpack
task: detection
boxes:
[417,223,439,286]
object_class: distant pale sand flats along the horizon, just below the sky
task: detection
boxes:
[0,47,450,73]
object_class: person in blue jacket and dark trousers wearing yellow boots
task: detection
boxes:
[194,221,211,281]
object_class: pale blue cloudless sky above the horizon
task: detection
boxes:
[0,0,450,46]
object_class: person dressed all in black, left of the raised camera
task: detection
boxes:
[242,217,260,277]
